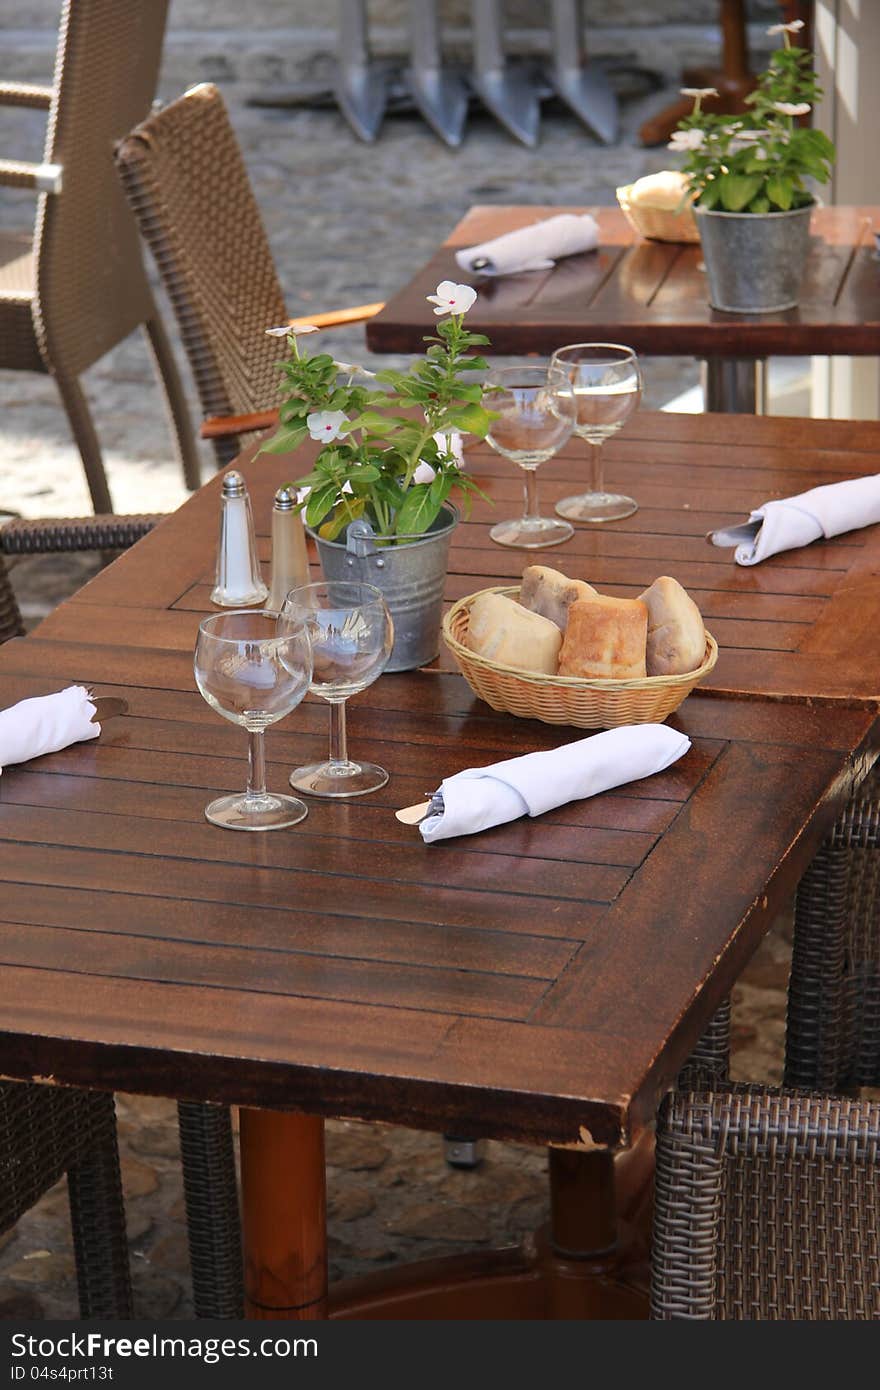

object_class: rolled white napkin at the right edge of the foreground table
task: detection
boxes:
[710,473,880,564]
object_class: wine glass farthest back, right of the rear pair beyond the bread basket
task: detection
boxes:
[551,343,642,521]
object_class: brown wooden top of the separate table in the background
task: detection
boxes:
[367,204,880,357]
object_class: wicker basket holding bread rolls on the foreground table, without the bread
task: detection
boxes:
[443,584,719,728]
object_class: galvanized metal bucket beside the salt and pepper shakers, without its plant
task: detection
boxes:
[309,502,459,671]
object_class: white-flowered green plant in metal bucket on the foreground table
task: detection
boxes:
[261,281,494,671]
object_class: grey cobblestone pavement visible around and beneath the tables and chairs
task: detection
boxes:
[0,29,788,1318]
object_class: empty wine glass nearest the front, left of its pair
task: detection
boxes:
[193,609,311,830]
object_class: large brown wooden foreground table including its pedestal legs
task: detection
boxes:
[0,416,880,1318]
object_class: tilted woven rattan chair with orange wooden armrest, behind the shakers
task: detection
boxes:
[115,83,382,466]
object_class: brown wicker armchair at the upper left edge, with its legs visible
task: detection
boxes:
[0,0,199,512]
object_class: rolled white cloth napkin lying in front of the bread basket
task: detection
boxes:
[418,724,691,844]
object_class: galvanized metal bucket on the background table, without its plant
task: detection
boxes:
[694,204,813,314]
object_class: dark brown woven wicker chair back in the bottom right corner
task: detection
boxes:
[651,1087,880,1321]
